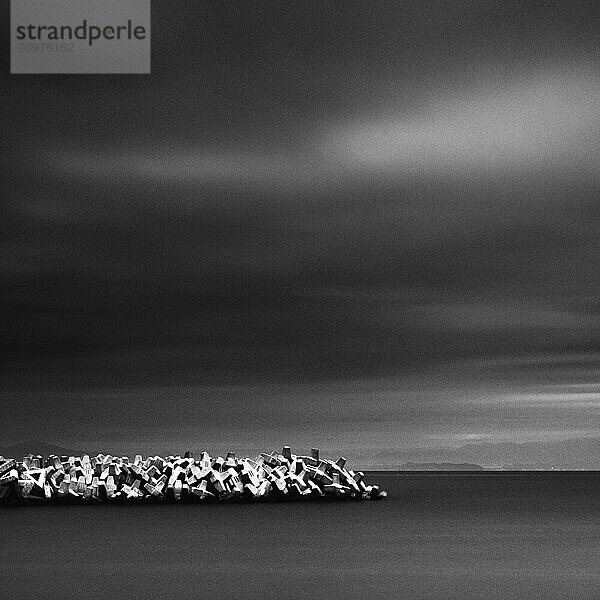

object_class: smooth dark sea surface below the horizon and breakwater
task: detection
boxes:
[0,474,600,600]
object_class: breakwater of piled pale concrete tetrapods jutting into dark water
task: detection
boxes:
[0,446,387,504]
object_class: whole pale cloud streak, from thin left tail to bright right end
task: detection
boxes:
[35,66,600,189]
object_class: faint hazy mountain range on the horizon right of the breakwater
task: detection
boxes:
[374,438,600,471]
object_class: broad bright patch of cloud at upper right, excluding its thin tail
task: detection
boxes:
[325,64,600,178]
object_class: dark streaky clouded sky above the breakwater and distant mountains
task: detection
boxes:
[0,0,600,459]
